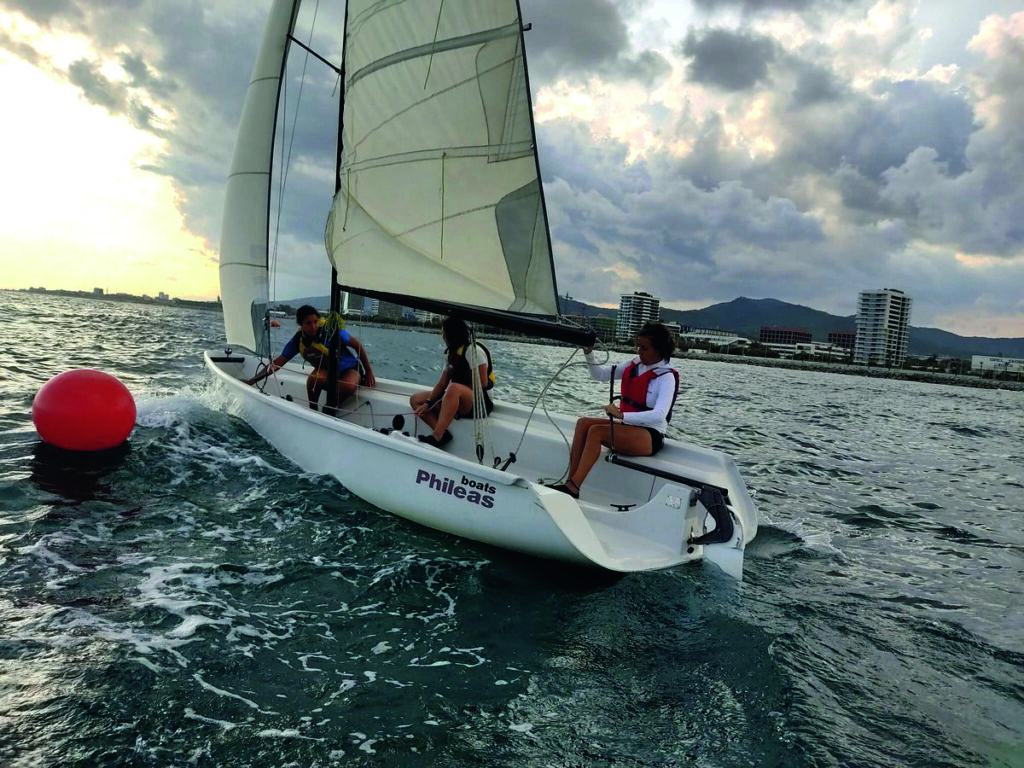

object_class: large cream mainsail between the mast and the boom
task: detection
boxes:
[326,0,558,316]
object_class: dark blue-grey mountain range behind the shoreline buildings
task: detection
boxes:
[280,296,1024,357]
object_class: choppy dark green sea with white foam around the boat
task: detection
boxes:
[0,291,1024,768]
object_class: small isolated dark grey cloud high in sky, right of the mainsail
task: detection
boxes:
[681,29,776,91]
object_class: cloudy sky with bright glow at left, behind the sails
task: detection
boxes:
[0,0,1024,337]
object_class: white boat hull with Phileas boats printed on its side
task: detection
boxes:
[206,352,757,578]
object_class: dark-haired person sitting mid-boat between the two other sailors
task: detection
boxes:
[409,316,495,447]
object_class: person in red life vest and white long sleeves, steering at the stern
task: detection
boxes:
[552,323,679,499]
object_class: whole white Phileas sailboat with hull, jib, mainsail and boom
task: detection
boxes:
[205,0,758,578]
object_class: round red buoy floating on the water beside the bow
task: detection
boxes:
[32,369,135,451]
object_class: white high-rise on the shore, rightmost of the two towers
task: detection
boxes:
[853,288,913,368]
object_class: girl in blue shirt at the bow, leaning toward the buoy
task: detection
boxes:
[246,304,377,413]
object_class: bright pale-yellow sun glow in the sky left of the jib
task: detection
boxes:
[0,45,219,298]
